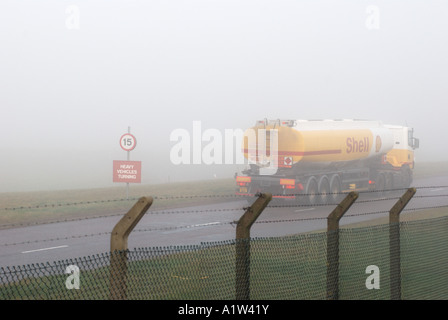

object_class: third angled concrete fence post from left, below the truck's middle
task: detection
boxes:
[327,191,358,300]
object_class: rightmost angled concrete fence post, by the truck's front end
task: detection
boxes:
[389,188,417,300]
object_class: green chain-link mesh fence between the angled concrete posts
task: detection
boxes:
[0,212,448,300]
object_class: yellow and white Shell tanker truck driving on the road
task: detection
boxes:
[236,119,419,205]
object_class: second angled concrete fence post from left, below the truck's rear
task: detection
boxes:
[235,193,272,300]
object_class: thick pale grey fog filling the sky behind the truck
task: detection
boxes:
[0,0,448,192]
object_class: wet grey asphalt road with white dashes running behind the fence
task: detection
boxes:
[0,176,448,267]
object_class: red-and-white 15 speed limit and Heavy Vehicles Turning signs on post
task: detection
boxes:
[113,127,141,200]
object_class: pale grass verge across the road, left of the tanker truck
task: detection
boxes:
[0,179,235,229]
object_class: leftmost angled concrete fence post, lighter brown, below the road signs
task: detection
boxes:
[109,197,153,300]
